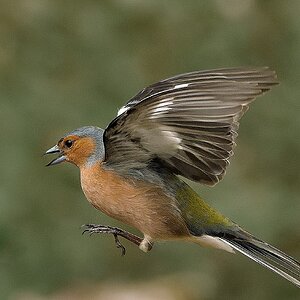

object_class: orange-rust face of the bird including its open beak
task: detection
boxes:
[46,135,96,167]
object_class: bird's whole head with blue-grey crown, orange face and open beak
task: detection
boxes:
[45,126,105,167]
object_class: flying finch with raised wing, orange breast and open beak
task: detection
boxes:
[45,67,300,288]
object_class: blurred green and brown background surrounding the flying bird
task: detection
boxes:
[0,0,300,300]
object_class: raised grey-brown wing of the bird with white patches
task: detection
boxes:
[104,67,277,185]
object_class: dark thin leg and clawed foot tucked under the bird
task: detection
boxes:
[81,224,152,256]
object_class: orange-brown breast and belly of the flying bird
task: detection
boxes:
[81,164,189,239]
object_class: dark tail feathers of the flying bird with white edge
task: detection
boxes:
[220,233,300,288]
